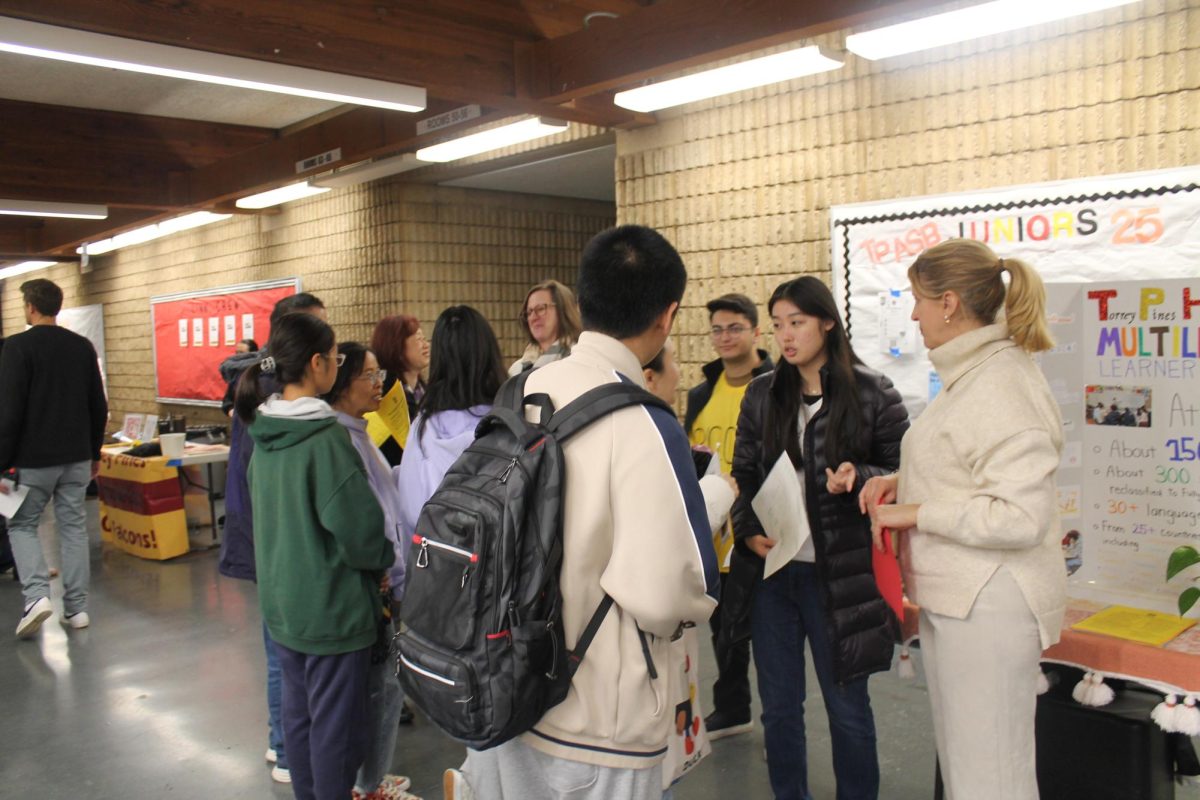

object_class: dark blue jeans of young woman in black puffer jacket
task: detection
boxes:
[750,561,880,800]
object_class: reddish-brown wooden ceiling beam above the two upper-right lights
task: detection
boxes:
[520,0,944,103]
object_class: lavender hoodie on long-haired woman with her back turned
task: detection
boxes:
[396,405,492,541]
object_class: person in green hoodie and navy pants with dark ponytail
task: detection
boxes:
[235,313,395,800]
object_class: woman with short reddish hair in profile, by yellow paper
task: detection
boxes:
[371,314,430,467]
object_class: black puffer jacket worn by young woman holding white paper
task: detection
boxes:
[722,366,908,684]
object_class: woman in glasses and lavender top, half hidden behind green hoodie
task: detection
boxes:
[325,342,416,800]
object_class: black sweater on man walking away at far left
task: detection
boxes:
[0,325,108,470]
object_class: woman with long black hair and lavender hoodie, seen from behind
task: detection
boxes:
[397,306,504,544]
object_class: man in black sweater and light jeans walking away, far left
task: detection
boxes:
[0,278,108,638]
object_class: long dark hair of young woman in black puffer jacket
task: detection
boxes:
[763,280,865,469]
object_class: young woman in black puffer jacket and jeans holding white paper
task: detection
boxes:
[724,276,908,800]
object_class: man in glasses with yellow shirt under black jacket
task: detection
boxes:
[684,294,772,739]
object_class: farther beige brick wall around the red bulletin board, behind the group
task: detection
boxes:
[2,180,613,428]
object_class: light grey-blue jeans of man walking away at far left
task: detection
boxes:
[8,461,91,616]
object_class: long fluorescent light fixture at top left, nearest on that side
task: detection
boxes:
[0,17,425,112]
